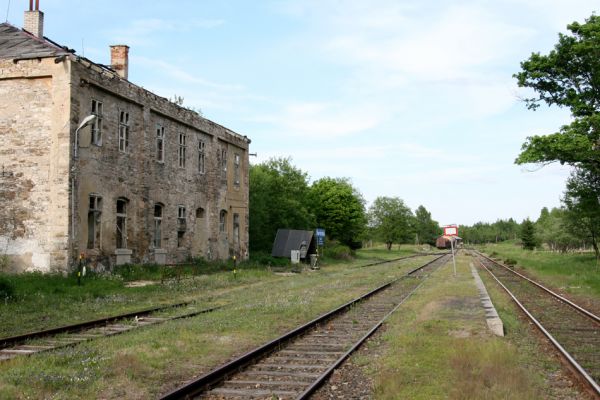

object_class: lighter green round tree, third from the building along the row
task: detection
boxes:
[369,197,414,250]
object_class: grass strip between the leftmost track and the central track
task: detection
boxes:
[0,248,433,399]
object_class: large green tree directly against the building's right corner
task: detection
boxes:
[249,158,315,251]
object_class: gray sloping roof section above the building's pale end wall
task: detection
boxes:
[0,22,70,59]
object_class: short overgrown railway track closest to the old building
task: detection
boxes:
[0,302,220,362]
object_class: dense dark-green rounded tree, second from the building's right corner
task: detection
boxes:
[309,177,367,248]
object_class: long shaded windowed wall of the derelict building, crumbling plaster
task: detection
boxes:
[71,63,249,263]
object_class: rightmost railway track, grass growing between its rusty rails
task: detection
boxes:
[476,252,600,398]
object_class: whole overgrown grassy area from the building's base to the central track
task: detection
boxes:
[0,249,434,399]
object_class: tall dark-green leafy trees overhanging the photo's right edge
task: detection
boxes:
[514,15,600,258]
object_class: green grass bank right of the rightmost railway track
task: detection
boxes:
[480,241,600,299]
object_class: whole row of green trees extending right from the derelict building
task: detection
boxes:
[250,158,440,251]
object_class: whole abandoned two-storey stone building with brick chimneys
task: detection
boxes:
[0,4,250,271]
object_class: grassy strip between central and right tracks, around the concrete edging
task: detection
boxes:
[364,256,578,400]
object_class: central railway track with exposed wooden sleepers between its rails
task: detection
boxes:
[161,254,450,400]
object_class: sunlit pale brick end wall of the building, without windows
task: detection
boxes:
[0,59,70,272]
